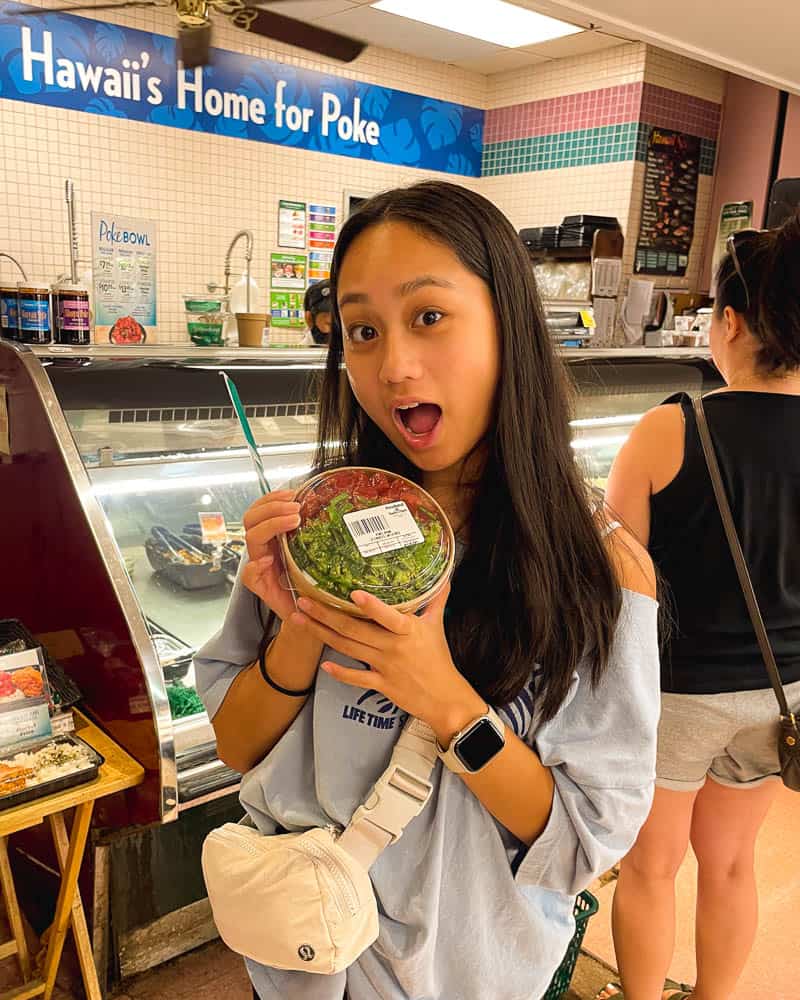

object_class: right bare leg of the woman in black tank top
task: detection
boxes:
[691,780,779,1000]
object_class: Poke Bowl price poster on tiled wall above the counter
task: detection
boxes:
[92,212,157,345]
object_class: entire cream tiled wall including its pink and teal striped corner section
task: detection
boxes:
[0,11,725,342]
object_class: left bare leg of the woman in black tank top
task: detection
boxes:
[612,788,697,1000]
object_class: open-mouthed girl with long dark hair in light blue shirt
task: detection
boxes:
[196,183,658,1000]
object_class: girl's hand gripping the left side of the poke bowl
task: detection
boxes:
[242,490,300,622]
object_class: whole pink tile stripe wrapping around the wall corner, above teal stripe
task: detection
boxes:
[483,82,721,143]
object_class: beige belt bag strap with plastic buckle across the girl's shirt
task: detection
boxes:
[337,717,438,870]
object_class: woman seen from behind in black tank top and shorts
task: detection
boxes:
[602,213,800,1000]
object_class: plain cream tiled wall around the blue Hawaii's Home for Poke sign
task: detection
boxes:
[0,1,488,343]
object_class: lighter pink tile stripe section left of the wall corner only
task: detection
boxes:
[483,83,642,142]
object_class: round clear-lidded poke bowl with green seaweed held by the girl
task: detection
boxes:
[281,467,456,618]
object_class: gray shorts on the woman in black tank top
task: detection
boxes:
[656,681,800,792]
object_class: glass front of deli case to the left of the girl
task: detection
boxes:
[42,351,323,804]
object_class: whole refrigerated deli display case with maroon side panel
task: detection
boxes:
[0,342,721,976]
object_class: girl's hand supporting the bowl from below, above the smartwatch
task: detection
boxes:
[290,587,486,746]
